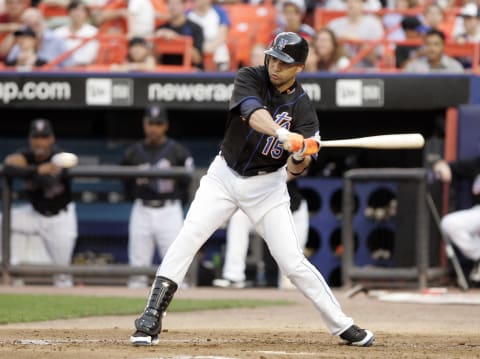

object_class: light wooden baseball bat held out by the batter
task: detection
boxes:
[320,133,425,150]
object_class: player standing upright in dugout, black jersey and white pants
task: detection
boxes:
[122,104,194,288]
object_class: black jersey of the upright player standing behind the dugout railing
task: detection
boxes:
[122,138,193,201]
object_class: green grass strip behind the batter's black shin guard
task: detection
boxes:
[0,294,291,324]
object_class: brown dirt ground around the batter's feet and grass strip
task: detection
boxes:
[0,286,480,359]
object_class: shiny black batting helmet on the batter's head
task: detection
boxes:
[265,32,308,64]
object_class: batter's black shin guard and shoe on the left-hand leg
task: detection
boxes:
[130,277,178,345]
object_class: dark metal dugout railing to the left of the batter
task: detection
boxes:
[0,165,196,285]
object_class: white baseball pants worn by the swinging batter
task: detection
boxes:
[157,156,353,335]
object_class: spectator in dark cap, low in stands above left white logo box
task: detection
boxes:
[111,37,156,71]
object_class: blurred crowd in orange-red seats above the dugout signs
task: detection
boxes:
[0,0,480,72]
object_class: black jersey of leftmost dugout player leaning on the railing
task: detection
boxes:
[18,146,72,216]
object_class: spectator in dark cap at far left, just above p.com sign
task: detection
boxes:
[5,26,47,70]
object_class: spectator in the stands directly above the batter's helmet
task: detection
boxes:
[272,0,315,41]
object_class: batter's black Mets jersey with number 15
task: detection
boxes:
[221,66,319,176]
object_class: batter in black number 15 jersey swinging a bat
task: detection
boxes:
[130,32,374,346]
